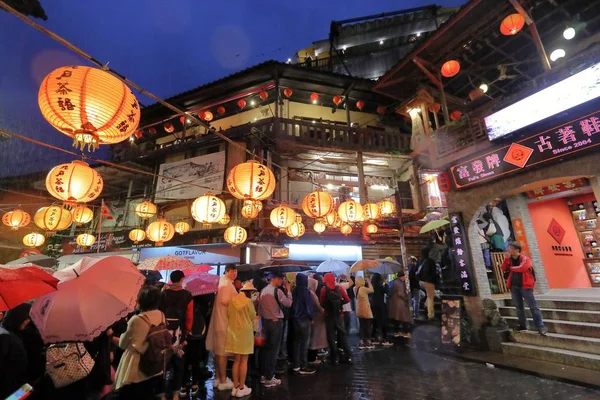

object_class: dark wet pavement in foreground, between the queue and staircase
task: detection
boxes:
[189,345,600,400]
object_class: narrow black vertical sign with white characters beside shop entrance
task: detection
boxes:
[450,213,477,296]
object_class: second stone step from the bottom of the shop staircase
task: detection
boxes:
[512,331,600,355]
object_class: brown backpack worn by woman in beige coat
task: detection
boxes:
[139,314,172,377]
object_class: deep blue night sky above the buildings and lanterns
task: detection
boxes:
[0,0,464,176]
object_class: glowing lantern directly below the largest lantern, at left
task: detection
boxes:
[46,161,104,203]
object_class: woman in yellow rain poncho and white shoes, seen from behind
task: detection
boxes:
[225,282,256,397]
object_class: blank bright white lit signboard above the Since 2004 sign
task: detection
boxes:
[485,64,600,140]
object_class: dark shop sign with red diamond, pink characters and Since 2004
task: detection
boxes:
[450,111,600,188]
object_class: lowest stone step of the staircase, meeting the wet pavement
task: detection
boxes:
[502,343,600,371]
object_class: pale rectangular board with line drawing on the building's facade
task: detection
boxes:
[156,151,225,203]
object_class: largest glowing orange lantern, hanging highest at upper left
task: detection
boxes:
[38,66,140,150]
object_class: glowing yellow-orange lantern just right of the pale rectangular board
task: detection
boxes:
[227,161,275,200]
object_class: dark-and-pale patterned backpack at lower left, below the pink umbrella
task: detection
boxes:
[46,343,95,388]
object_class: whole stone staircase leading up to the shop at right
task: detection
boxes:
[498,299,600,371]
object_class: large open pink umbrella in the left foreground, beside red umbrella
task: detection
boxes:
[30,256,144,343]
